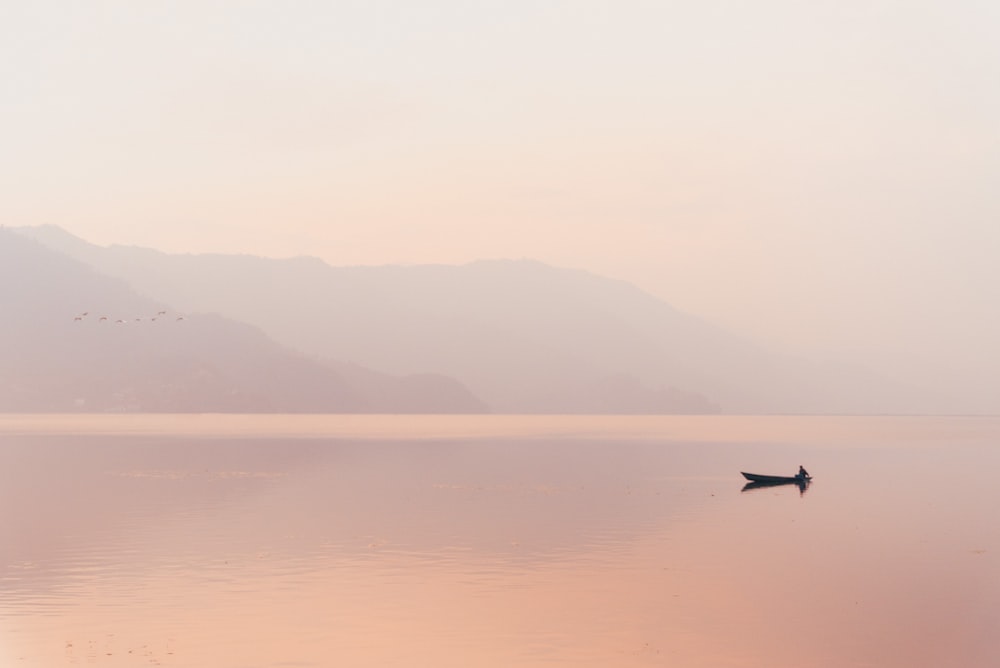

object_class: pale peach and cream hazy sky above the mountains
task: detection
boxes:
[0,0,1000,380]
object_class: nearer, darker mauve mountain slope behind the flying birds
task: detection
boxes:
[0,230,485,412]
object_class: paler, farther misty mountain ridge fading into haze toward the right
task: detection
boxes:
[11,227,940,413]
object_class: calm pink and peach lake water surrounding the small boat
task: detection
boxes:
[0,416,1000,668]
